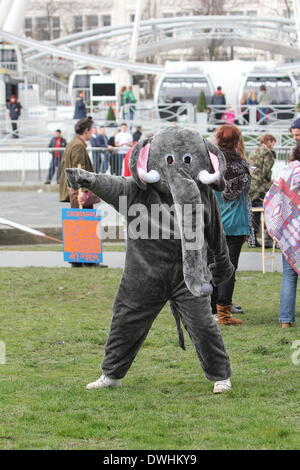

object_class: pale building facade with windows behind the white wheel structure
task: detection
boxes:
[24,0,293,63]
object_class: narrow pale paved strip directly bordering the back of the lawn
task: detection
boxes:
[0,251,282,272]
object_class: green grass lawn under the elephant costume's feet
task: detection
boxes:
[0,268,300,450]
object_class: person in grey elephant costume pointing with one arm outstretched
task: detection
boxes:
[65,126,234,393]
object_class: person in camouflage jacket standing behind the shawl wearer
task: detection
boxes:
[249,134,276,247]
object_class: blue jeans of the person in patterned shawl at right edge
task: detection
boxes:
[279,255,298,323]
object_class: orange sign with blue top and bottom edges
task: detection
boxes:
[62,208,103,264]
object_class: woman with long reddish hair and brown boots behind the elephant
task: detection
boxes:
[212,124,252,325]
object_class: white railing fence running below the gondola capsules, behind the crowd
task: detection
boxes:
[0,102,297,141]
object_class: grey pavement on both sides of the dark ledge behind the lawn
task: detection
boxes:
[0,189,282,272]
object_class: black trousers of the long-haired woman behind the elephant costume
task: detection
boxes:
[209,235,246,314]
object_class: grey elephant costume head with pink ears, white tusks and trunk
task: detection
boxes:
[130,126,226,296]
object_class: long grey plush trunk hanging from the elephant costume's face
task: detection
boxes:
[165,168,212,297]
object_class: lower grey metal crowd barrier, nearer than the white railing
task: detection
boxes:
[0,145,291,185]
